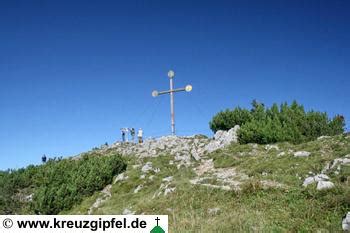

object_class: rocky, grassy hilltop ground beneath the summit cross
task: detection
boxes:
[74,126,350,232]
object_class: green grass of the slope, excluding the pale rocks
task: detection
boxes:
[63,136,350,232]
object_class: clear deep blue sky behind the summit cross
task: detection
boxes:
[0,0,350,169]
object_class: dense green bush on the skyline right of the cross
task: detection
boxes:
[209,100,345,144]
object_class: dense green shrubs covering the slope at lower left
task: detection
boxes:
[0,155,126,214]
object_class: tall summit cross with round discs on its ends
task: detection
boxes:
[152,70,192,135]
